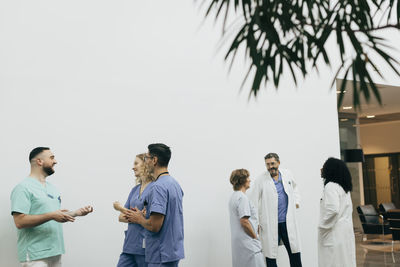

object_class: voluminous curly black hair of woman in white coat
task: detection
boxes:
[321,158,353,193]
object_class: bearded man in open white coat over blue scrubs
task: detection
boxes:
[249,153,302,267]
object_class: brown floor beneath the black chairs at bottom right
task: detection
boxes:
[356,234,400,267]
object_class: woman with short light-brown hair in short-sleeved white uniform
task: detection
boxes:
[229,169,265,267]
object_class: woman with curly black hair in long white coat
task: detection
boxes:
[318,158,356,267]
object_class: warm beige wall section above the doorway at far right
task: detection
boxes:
[360,122,400,154]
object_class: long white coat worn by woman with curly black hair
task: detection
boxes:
[318,182,356,267]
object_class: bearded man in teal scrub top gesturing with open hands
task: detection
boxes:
[11,147,93,267]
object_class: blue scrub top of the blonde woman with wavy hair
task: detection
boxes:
[123,183,152,255]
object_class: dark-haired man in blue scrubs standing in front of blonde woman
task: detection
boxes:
[126,144,184,267]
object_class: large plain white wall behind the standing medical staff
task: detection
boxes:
[0,0,339,267]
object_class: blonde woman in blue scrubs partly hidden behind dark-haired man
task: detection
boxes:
[117,154,152,267]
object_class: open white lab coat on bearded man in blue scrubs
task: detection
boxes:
[248,169,300,259]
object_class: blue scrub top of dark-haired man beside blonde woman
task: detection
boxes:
[145,175,185,263]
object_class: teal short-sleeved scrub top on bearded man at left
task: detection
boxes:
[11,177,65,262]
